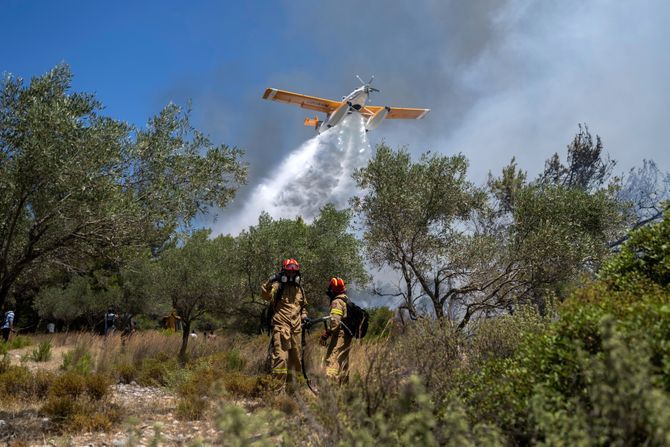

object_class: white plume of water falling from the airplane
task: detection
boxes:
[219,114,371,234]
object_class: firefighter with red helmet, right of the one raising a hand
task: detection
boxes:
[320,278,353,383]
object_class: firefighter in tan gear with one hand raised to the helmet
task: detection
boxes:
[261,259,307,391]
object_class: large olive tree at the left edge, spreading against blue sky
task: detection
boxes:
[0,65,246,312]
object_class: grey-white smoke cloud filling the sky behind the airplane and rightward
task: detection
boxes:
[171,0,670,234]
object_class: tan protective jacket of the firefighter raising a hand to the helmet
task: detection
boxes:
[261,281,307,333]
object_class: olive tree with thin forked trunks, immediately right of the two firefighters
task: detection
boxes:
[353,144,486,318]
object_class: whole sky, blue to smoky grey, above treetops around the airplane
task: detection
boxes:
[0,0,670,228]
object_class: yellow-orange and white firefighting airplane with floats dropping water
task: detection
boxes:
[263,76,430,133]
